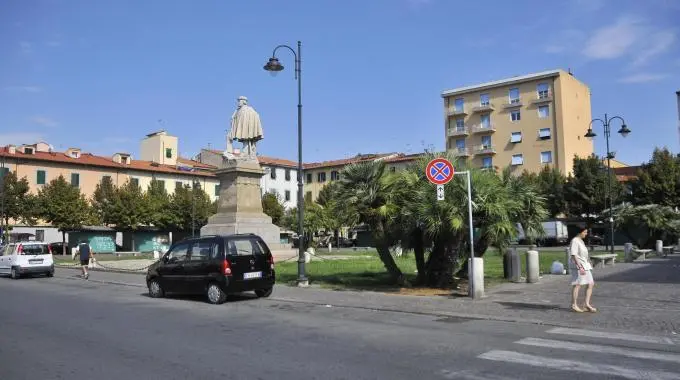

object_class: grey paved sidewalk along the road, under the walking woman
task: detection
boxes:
[58,255,680,338]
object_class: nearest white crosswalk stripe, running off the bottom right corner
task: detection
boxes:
[478,350,680,380]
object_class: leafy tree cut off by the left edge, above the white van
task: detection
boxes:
[0,172,36,226]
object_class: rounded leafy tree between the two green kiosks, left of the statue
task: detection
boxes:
[109,180,147,230]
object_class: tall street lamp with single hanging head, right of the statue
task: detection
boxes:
[264,41,309,286]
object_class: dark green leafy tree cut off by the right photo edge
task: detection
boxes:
[631,148,680,207]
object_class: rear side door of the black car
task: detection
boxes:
[184,238,220,294]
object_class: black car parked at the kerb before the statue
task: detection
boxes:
[146,234,275,304]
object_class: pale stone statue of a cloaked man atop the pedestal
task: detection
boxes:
[224,96,264,157]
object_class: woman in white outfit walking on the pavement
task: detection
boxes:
[569,228,597,313]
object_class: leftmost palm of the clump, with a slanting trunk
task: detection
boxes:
[337,161,405,284]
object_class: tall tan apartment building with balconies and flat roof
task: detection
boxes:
[441,70,593,174]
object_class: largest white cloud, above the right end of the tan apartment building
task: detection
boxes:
[582,17,645,59]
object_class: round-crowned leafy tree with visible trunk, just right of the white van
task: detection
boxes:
[37,175,94,254]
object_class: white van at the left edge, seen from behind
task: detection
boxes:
[0,241,54,279]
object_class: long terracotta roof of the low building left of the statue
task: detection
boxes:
[0,146,214,177]
